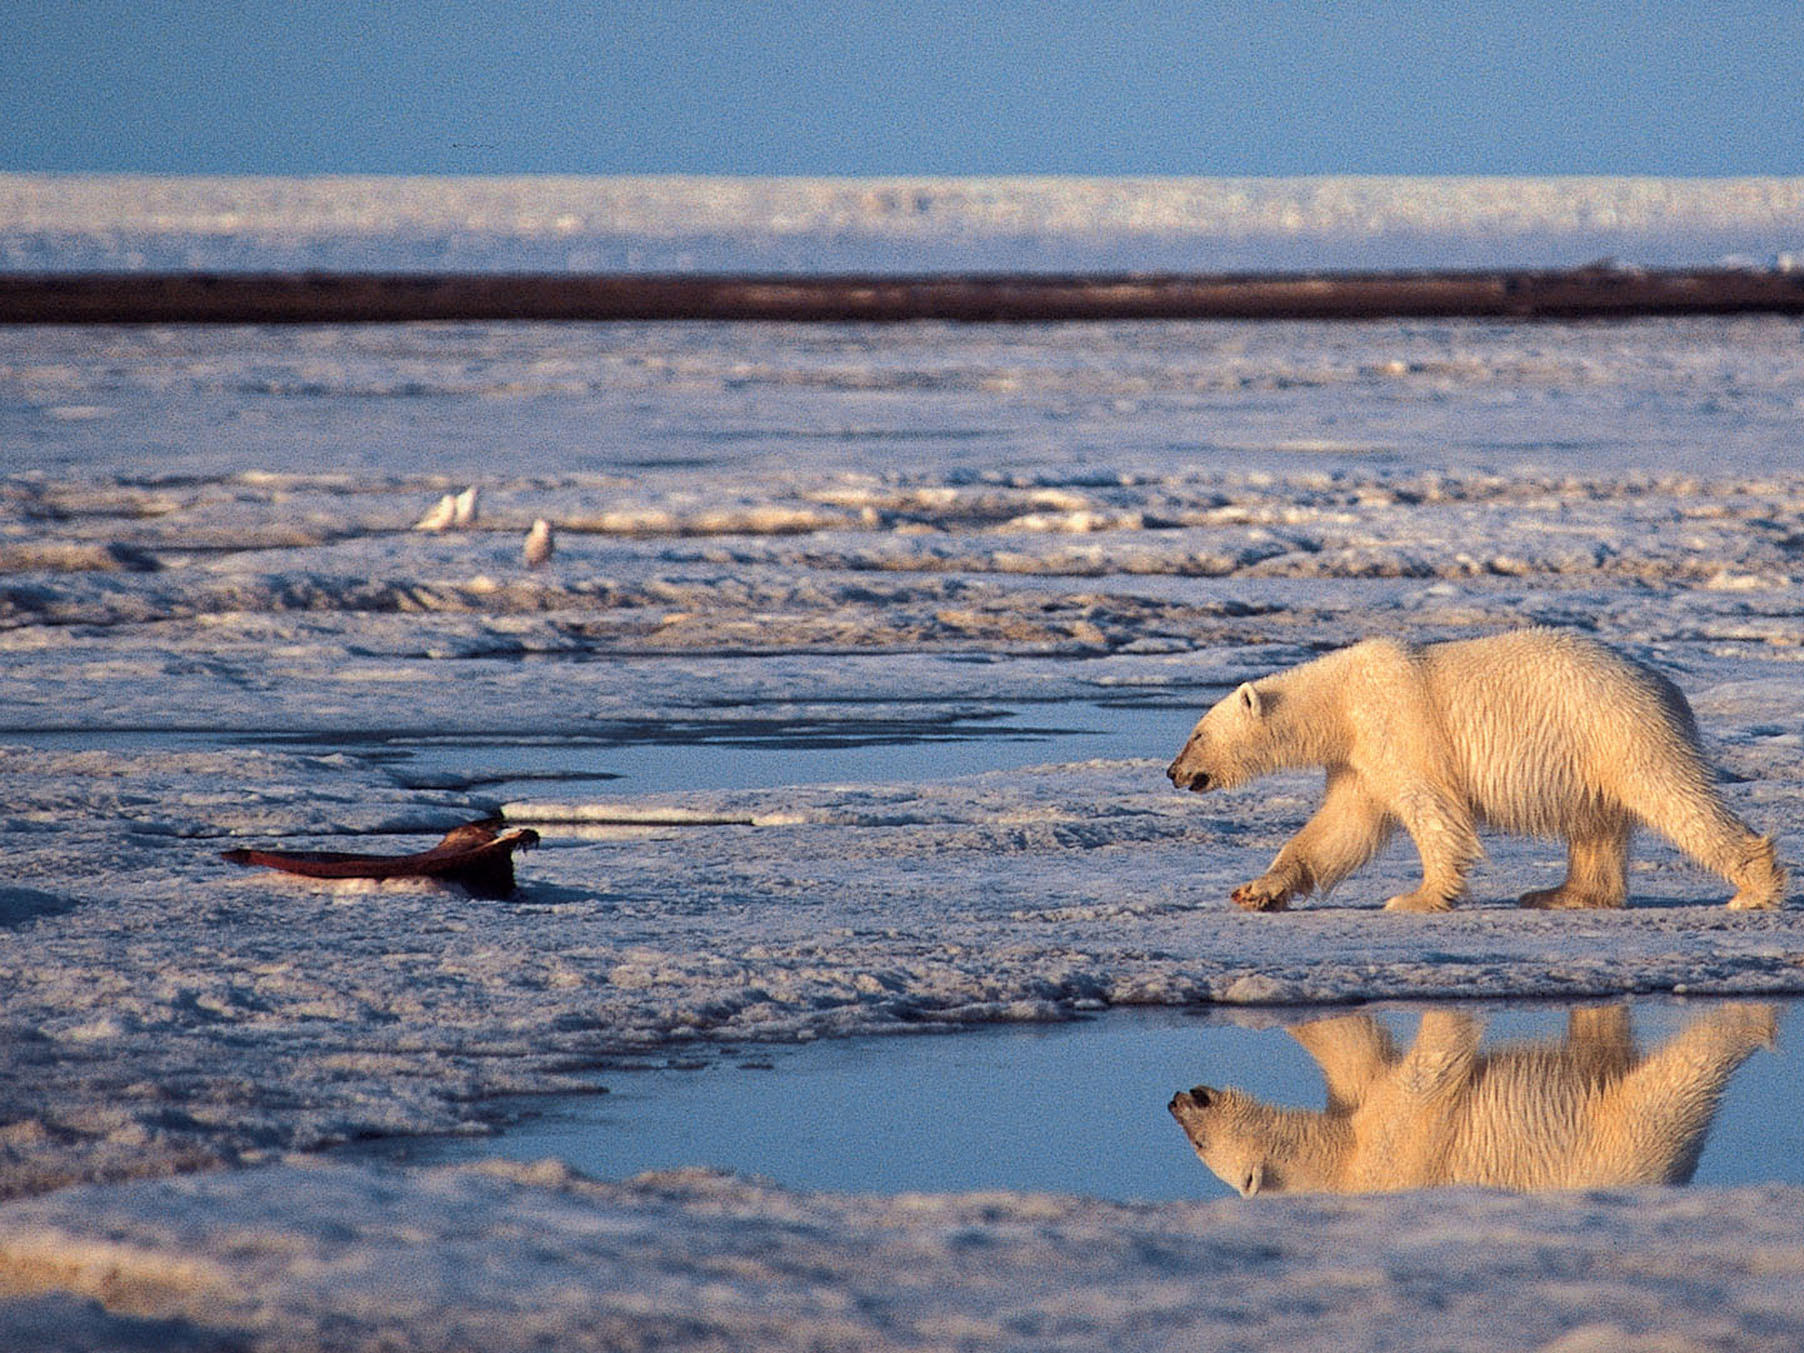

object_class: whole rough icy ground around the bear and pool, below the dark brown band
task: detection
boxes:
[0,259,1804,1349]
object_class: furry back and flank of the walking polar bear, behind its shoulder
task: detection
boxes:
[1418,630,1708,837]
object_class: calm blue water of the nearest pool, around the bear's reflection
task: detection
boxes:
[364,999,1804,1200]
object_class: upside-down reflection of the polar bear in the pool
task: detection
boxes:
[1171,1005,1777,1196]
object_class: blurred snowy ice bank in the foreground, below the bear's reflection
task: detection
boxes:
[0,1162,1804,1353]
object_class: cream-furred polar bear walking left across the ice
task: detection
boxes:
[1165,630,1786,911]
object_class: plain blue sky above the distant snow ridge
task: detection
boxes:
[0,0,1804,175]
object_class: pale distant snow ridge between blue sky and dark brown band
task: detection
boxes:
[0,175,1804,271]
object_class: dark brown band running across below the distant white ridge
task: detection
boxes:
[0,267,1804,325]
